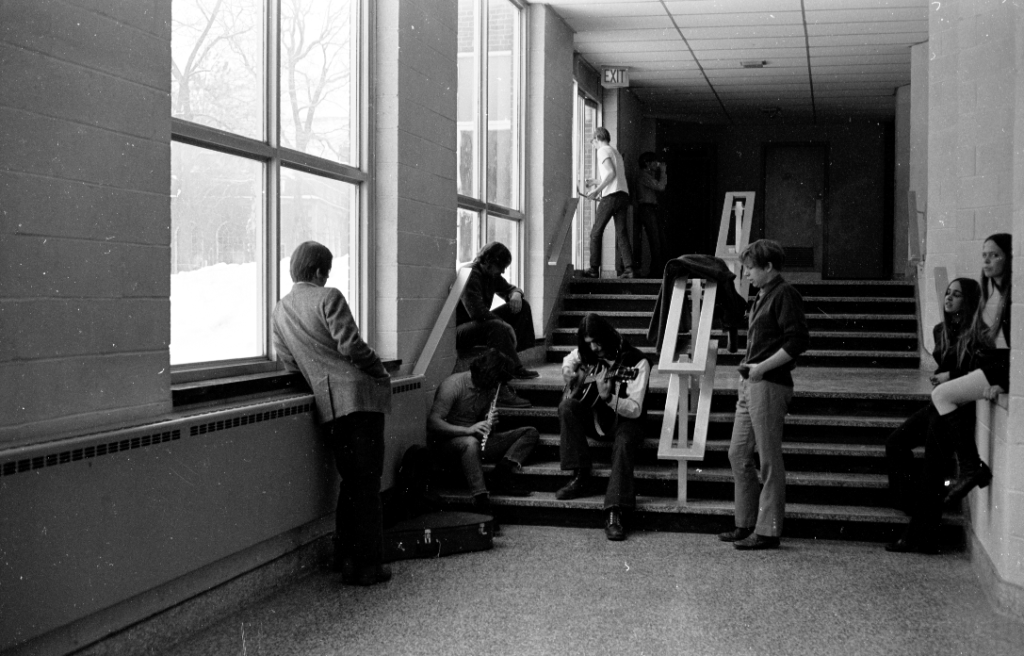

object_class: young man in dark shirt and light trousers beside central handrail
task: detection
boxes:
[719,239,809,550]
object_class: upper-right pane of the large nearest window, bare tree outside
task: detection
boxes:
[281,0,358,164]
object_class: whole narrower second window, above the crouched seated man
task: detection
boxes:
[457,0,523,280]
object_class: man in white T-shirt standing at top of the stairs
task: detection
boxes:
[583,128,633,278]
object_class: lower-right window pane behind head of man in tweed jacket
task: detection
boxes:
[279,168,358,302]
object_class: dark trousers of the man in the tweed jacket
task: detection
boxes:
[324,412,384,567]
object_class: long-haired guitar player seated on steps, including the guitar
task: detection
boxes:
[555,313,650,540]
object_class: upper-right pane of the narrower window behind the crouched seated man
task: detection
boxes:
[486,0,519,209]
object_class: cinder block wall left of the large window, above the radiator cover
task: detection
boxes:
[0,0,171,446]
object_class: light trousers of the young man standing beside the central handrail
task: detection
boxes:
[729,379,793,537]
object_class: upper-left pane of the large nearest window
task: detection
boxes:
[171,0,265,139]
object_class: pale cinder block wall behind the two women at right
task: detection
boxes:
[924,0,1024,597]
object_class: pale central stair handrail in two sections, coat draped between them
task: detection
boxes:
[657,191,755,504]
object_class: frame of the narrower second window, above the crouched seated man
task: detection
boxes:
[456,0,529,285]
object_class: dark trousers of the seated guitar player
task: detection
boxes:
[558,399,643,510]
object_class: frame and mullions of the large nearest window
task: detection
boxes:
[170,0,375,385]
